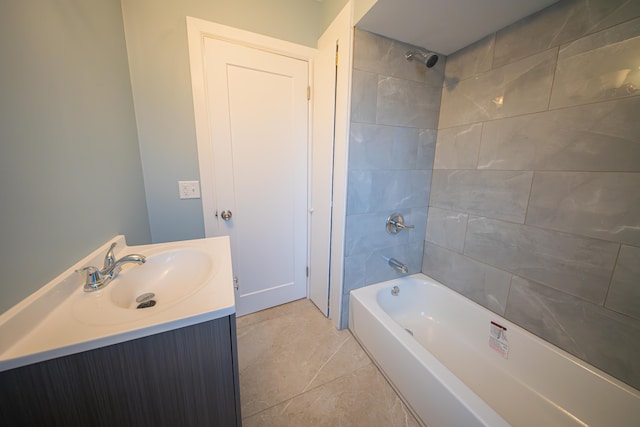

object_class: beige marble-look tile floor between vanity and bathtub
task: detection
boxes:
[237,299,420,427]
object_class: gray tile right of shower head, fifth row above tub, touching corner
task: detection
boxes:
[438,49,557,129]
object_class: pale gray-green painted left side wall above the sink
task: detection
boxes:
[0,0,150,312]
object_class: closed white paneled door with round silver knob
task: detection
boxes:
[203,38,309,315]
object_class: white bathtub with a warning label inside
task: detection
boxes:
[349,274,640,427]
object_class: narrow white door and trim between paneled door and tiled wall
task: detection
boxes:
[309,2,353,328]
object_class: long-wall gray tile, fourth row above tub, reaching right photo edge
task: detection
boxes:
[478,97,640,172]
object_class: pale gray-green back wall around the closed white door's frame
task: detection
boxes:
[122,0,344,242]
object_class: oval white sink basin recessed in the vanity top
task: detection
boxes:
[110,249,214,310]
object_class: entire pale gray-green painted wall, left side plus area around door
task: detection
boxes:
[0,0,346,311]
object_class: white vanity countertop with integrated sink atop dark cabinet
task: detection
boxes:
[0,236,235,371]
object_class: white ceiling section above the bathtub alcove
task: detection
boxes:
[356,0,558,55]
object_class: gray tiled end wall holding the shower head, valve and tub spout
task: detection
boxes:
[342,30,444,327]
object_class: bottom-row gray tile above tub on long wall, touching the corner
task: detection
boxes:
[422,243,511,315]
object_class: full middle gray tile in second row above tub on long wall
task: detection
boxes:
[464,217,619,304]
